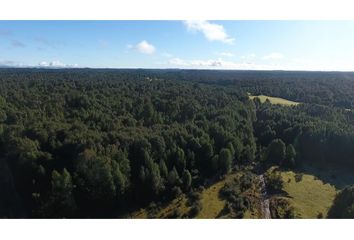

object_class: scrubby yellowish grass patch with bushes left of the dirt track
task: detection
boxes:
[131,173,260,219]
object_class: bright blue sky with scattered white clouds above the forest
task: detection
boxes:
[0,20,354,71]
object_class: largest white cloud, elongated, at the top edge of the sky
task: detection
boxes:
[184,20,235,44]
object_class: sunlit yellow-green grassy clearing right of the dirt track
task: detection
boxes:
[281,171,336,218]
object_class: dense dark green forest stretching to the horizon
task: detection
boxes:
[0,69,354,218]
